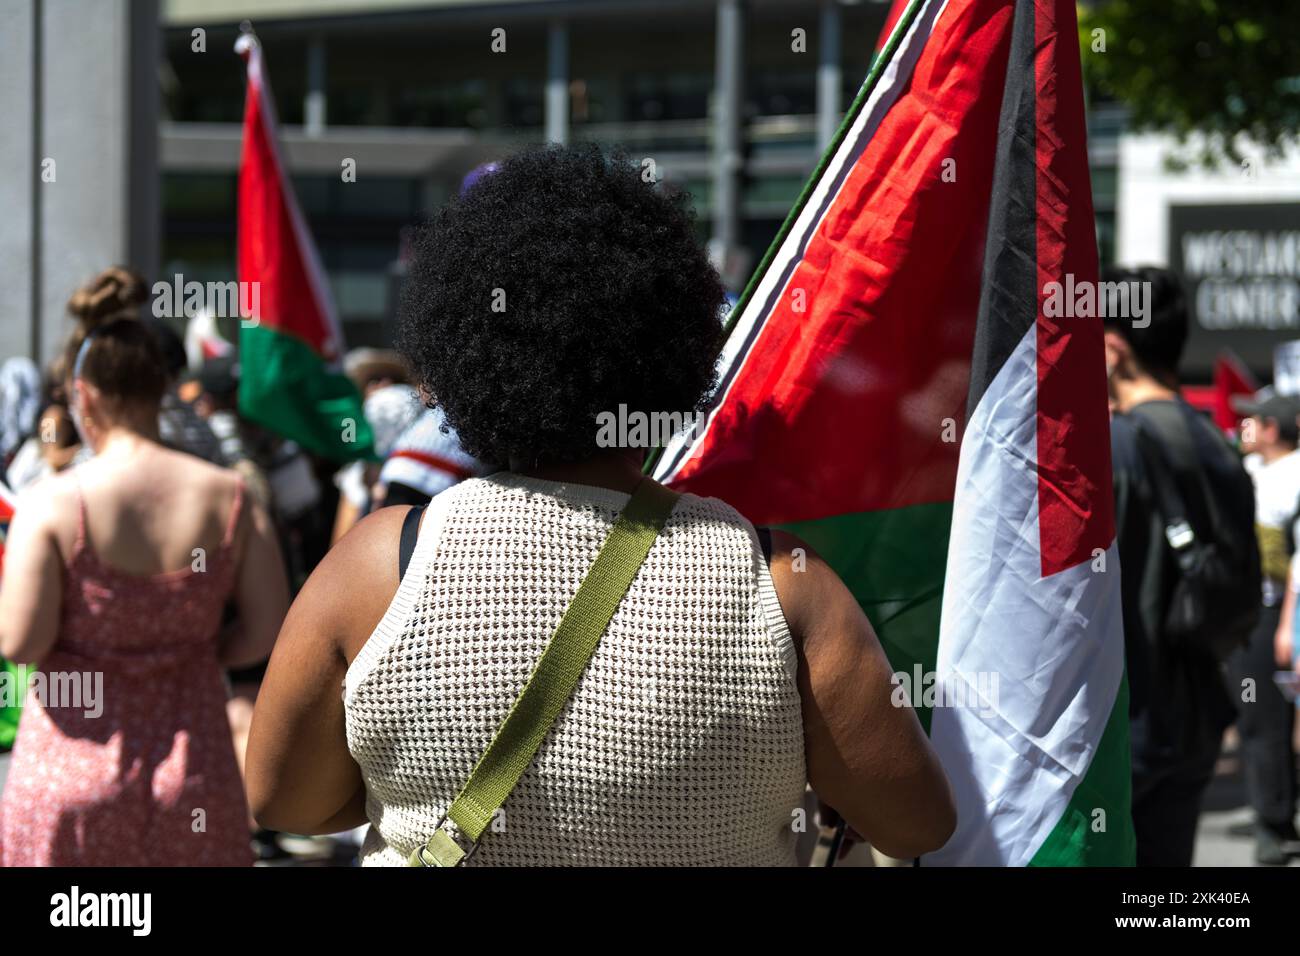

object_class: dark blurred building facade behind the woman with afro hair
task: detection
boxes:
[160,0,1117,343]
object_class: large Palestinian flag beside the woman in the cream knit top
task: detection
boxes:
[654,0,1134,865]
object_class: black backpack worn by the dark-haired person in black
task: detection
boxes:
[1130,410,1260,661]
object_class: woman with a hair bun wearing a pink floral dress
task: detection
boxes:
[0,271,287,866]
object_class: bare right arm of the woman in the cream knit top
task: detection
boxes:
[771,531,957,858]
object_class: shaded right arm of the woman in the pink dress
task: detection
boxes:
[218,498,289,667]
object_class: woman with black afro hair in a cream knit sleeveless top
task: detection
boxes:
[248,146,956,866]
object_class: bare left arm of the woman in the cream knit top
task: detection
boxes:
[246,507,407,834]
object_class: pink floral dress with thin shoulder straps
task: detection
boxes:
[0,484,252,866]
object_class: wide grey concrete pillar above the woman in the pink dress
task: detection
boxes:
[0,0,159,362]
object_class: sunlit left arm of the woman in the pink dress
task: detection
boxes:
[0,481,64,663]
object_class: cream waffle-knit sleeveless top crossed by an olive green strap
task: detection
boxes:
[343,472,805,866]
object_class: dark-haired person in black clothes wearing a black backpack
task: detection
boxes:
[1105,267,1258,866]
